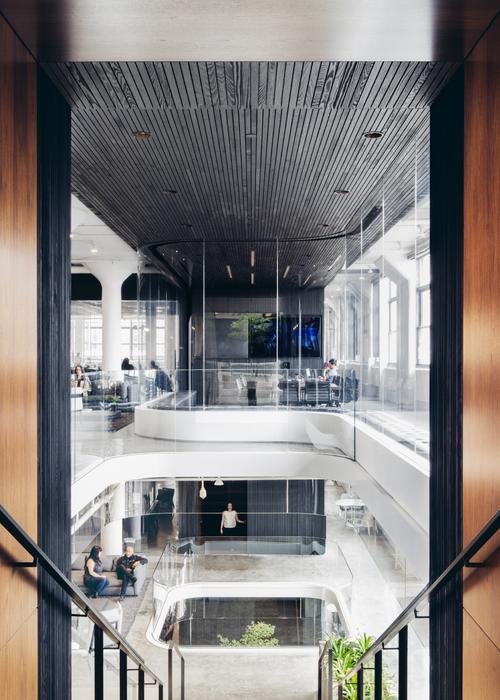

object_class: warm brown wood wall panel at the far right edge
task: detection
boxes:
[463,13,500,700]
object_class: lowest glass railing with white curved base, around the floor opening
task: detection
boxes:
[151,536,352,646]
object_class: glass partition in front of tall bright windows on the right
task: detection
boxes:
[325,132,430,463]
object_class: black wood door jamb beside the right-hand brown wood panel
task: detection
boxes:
[429,70,464,700]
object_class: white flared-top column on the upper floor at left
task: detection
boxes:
[86,261,137,371]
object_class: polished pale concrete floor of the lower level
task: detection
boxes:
[111,484,428,700]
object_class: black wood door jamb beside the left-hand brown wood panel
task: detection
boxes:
[37,65,71,700]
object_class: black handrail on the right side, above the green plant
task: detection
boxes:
[319,510,500,697]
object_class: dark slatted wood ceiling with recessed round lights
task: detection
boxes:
[45,62,455,285]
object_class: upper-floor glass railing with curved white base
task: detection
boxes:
[71,366,356,480]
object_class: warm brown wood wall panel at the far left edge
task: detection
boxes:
[0,12,38,700]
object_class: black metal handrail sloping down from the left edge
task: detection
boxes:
[0,505,164,686]
